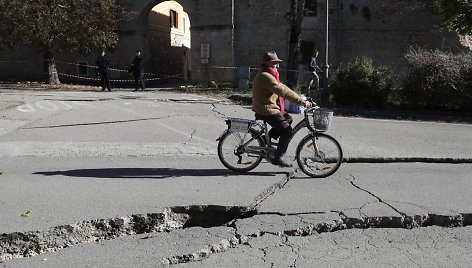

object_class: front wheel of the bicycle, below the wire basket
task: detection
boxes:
[296,133,343,178]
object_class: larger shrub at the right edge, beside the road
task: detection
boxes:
[400,49,472,112]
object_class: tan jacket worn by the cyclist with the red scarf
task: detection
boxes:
[252,71,303,115]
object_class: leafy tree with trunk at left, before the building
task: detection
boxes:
[0,0,128,84]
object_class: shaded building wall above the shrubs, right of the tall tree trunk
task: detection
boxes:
[302,0,467,73]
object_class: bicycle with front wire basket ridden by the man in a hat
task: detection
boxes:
[217,104,343,178]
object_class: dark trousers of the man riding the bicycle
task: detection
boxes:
[256,113,293,158]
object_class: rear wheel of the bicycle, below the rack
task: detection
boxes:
[218,129,264,172]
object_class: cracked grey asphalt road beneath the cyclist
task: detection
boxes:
[0,90,472,267]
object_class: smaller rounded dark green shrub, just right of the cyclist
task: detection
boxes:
[331,57,393,108]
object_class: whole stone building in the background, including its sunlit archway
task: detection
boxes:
[0,0,467,85]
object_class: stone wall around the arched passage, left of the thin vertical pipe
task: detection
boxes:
[117,0,234,82]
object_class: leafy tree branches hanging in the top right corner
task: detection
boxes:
[392,0,472,35]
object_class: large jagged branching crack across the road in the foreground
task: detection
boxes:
[0,173,472,265]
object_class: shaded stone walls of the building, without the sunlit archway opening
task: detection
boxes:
[0,0,470,82]
